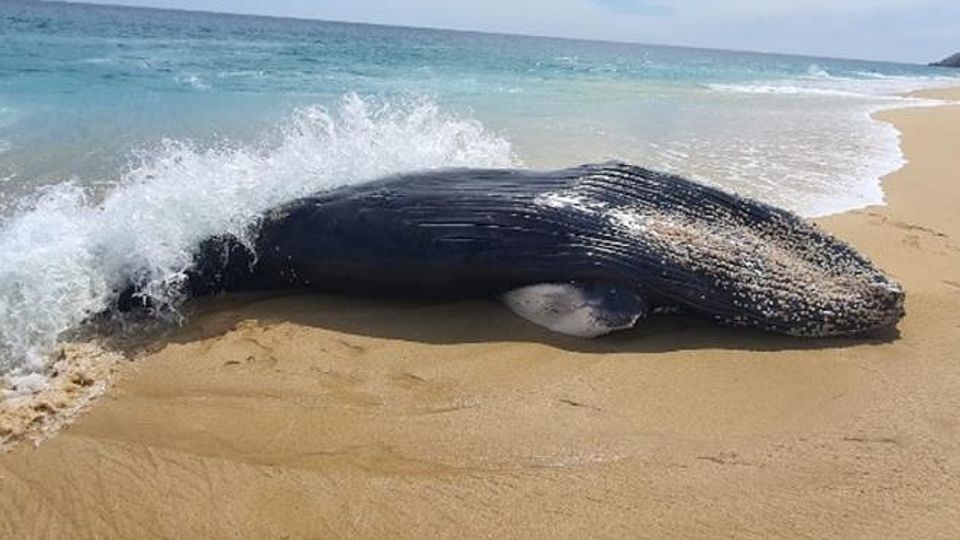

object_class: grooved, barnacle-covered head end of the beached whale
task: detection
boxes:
[542,164,904,337]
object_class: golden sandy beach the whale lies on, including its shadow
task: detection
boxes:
[0,91,960,538]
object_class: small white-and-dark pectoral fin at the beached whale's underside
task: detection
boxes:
[501,283,648,338]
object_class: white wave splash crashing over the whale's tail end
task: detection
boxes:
[0,94,515,377]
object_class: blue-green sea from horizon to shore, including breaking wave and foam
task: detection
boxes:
[0,0,960,377]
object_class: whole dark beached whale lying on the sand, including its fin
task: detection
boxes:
[180,163,904,337]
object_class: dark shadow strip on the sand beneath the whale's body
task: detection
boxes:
[142,293,900,353]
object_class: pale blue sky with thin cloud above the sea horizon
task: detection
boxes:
[69,0,960,63]
